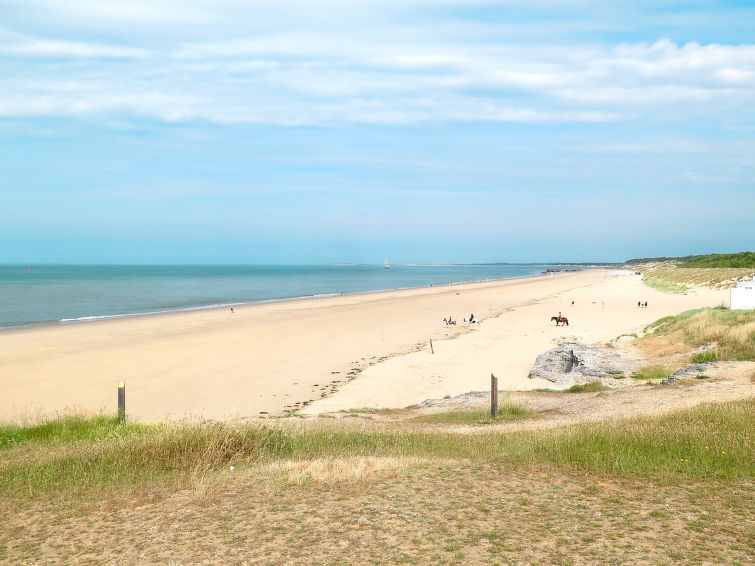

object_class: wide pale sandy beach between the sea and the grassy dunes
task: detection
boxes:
[0,270,728,421]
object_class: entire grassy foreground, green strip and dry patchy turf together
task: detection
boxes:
[0,400,755,564]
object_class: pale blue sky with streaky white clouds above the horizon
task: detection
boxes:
[0,0,755,264]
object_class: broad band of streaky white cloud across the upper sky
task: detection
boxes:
[0,0,755,124]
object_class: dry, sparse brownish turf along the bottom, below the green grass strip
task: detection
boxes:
[0,460,755,566]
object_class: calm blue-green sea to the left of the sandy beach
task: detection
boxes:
[0,264,568,330]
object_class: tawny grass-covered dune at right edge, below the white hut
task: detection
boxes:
[645,307,755,363]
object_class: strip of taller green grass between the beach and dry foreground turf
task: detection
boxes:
[0,399,755,497]
